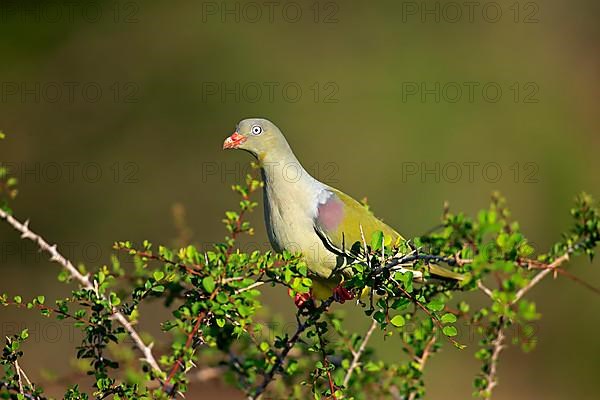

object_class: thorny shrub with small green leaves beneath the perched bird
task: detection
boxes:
[0,160,600,399]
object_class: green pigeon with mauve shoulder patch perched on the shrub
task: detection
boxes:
[223,118,464,307]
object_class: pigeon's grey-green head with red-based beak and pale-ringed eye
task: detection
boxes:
[223,118,288,160]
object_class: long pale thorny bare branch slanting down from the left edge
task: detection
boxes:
[0,209,162,374]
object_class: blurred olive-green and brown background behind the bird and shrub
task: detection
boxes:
[0,0,600,400]
